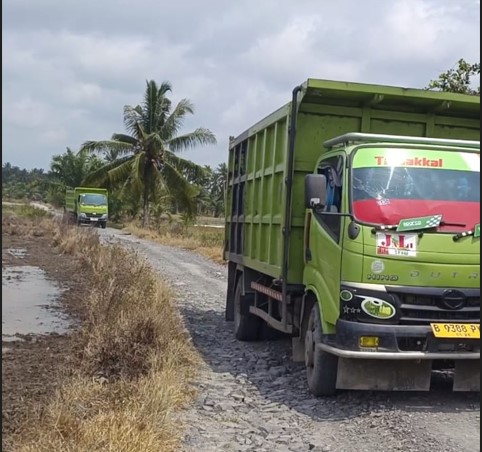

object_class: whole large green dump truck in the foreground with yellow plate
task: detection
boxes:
[224,79,480,395]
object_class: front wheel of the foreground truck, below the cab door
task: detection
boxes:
[305,303,338,396]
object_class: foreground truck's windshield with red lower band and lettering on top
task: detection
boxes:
[351,148,480,232]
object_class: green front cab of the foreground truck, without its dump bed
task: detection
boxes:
[303,133,480,390]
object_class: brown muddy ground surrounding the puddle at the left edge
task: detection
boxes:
[2,219,87,451]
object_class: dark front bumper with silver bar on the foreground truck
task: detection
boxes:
[317,320,480,360]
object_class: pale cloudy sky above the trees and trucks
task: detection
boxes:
[2,0,480,169]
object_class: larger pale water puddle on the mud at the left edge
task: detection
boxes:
[2,265,70,340]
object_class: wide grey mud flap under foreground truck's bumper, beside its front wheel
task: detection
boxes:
[336,358,432,391]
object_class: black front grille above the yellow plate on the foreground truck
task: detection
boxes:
[393,293,480,325]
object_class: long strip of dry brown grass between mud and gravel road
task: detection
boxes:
[9,217,199,452]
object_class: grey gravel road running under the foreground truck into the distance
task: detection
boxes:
[99,228,480,452]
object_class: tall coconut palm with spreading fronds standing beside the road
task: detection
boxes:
[80,80,216,226]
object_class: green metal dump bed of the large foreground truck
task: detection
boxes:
[225,79,480,284]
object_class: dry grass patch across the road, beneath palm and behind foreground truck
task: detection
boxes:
[124,222,226,264]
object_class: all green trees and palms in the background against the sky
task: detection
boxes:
[2,59,480,226]
